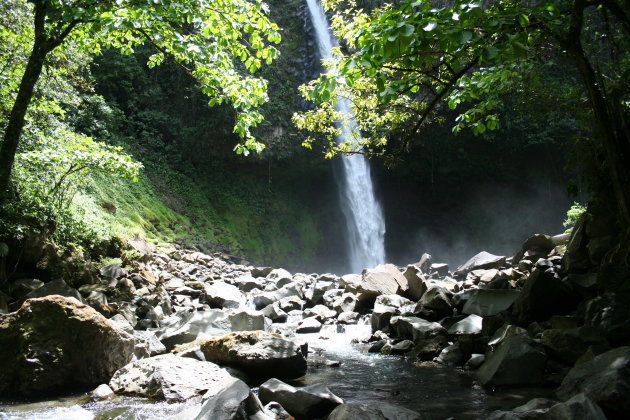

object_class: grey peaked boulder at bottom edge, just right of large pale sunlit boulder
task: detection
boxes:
[190,378,275,420]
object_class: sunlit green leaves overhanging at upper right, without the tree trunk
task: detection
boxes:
[294,0,628,159]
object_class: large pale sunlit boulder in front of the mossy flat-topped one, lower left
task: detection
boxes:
[109,354,233,402]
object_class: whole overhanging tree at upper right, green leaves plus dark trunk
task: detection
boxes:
[294,0,630,220]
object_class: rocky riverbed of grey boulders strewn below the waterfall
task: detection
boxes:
[0,218,630,419]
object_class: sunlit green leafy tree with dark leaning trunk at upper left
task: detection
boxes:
[0,0,280,196]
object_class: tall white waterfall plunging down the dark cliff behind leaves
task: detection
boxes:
[306,0,385,273]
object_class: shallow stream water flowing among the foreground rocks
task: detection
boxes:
[0,325,551,420]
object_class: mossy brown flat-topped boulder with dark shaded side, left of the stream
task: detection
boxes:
[201,331,308,379]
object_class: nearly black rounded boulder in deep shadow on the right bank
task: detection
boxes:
[512,268,578,324]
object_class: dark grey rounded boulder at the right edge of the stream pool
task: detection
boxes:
[477,334,547,386]
